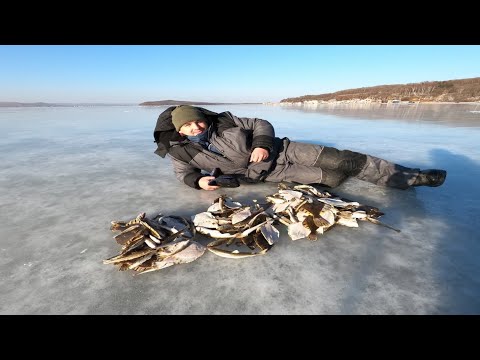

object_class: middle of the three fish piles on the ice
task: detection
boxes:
[192,195,279,259]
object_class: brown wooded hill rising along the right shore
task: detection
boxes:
[280,77,480,103]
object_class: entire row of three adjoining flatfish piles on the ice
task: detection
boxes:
[103,183,400,273]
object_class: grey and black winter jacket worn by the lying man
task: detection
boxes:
[153,106,282,189]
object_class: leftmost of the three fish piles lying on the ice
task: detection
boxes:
[103,213,205,273]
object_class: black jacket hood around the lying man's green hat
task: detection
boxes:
[153,106,218,158]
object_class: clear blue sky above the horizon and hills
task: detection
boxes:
[0,45,480,103]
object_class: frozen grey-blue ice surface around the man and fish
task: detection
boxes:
[0,104,480,314]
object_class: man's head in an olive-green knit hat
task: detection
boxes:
[172,105,208,136]
